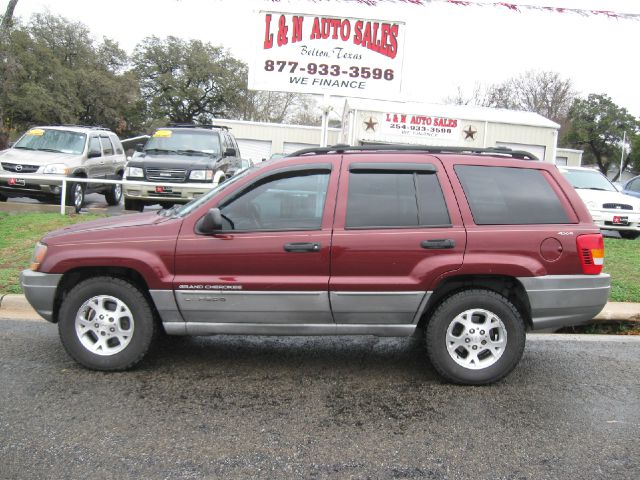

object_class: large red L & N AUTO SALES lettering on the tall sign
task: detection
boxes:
[264,14,399,58]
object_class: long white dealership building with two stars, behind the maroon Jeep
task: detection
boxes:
[216,99,582,166]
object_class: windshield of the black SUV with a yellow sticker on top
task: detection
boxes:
[144,130,220,156]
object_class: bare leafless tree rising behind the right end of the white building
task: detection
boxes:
[486,70,576,124]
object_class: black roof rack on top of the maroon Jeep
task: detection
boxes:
[288,143,539,161]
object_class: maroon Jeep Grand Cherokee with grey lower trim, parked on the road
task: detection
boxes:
[22,146,610,384]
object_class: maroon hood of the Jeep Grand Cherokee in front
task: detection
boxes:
[42,212,182,244]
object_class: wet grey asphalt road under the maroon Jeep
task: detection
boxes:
[0,320,640,479]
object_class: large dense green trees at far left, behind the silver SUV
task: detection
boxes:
[0,14,140,144]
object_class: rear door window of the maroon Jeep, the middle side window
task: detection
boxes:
[345,170,450,228]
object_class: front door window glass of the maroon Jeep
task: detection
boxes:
[220,171,329,231]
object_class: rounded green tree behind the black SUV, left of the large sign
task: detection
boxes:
[133,37,247,122]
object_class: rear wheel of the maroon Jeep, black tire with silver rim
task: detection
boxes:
[426,289,526,385]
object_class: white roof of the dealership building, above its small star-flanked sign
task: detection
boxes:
[345,98,560,129]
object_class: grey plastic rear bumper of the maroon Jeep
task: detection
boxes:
[518,273,611,330]
